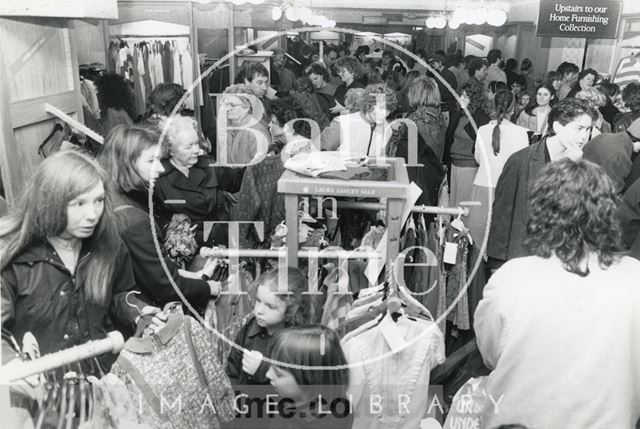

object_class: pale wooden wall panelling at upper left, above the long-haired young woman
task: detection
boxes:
[0,18,82,204]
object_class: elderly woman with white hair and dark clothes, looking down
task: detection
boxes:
[154,116,244,244]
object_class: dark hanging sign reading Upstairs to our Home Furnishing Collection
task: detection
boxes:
[538,0,622,39]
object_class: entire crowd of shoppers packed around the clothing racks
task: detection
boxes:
[0,37,640,428]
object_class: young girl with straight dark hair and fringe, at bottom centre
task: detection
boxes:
[267,325,353,429]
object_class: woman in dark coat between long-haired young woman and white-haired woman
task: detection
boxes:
[99,126,220,309]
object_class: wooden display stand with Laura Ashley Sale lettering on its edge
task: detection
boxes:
[278,158,409,267]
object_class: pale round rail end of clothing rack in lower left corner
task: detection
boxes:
[0,331,124,385]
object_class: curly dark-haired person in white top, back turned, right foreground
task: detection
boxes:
[474,159,640,428]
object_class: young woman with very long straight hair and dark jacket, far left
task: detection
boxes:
[0,150,145,373]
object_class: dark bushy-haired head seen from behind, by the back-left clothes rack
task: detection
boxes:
[95,73,135,135]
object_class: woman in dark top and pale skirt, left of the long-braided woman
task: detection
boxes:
[449,83,489,205]
